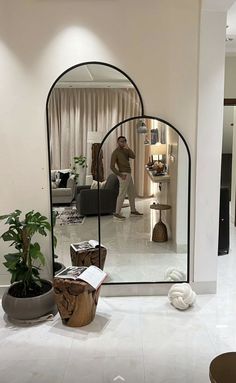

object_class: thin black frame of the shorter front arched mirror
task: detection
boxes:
[97,114,191,285]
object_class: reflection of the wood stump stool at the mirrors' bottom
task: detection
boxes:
[70,246,107,270]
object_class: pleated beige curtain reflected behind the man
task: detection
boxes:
[48,88,150,197]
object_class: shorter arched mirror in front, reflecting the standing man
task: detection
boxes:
[99,116,190,284]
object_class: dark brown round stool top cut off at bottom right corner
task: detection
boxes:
[209,352,236,383]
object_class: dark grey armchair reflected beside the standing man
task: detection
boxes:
[76,174,119,216]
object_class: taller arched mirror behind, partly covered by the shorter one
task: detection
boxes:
[47,62,143,271]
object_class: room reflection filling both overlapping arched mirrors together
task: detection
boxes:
[47,64,190,283]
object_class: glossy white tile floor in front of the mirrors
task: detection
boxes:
[0,227,236,383]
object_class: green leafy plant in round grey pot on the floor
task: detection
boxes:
[0,210,56,319]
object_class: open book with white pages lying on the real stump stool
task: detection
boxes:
[55,266,107,290]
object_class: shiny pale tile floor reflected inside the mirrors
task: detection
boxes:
[55,198,187,282]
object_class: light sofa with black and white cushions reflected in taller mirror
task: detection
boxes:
[51,169,76,205]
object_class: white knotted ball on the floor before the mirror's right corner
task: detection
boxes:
[168,283,196,310]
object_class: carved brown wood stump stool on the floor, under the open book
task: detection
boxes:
[53,277,100,327]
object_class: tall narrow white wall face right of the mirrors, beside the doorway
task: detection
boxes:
[193,11,226,290]
